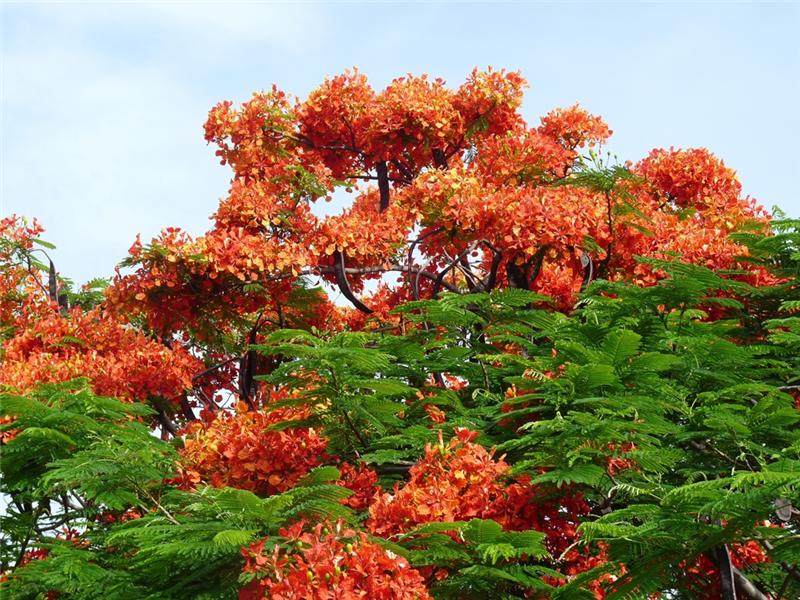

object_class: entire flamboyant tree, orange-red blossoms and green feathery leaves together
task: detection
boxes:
[0,70,800,600]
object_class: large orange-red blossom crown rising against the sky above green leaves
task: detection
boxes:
[108,70,765,338]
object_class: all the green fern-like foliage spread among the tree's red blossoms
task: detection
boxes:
[0,221,800,600]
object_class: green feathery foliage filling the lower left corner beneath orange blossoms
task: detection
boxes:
[0,382,353,599]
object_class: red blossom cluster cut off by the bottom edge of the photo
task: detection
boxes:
[239,521,431,600]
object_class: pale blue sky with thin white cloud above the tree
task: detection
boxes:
[0,2,800,283]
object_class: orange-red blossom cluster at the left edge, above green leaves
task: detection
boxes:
[0,217,202,412]
